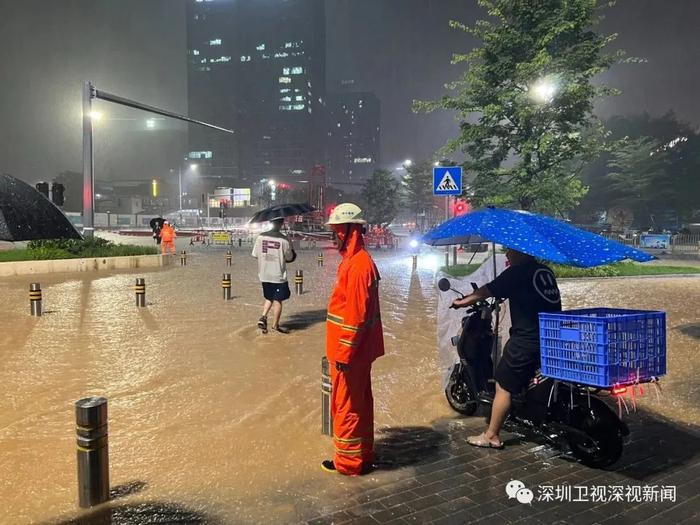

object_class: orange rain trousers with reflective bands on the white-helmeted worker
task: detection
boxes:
[331,363,374,476]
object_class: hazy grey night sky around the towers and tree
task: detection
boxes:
[0,0,700,182]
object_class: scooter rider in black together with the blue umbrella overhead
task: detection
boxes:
[422,206,654,448]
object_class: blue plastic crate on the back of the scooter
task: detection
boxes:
[540,308,666,388]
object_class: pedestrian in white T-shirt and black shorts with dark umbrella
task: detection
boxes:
[250,204,313,334]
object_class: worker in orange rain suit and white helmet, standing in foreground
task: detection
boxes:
[321,203,384,476]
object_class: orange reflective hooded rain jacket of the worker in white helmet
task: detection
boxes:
[326,227,384,367]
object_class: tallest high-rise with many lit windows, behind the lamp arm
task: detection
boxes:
[187,0,326,186]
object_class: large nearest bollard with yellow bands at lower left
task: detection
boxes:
[75,397,109,508]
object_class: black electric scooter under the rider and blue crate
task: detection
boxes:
[438,279,629,468]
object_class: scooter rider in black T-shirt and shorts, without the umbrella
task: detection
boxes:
[452,249,561,449]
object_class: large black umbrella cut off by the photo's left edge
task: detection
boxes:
[0,174,81,241]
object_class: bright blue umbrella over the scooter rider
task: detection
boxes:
[422,207,654,268]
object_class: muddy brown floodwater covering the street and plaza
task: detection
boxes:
[0,245,700,523]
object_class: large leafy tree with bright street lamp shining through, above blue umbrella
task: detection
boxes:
[414,0,621,213]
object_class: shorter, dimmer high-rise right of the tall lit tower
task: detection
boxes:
[326,92,381,186]
